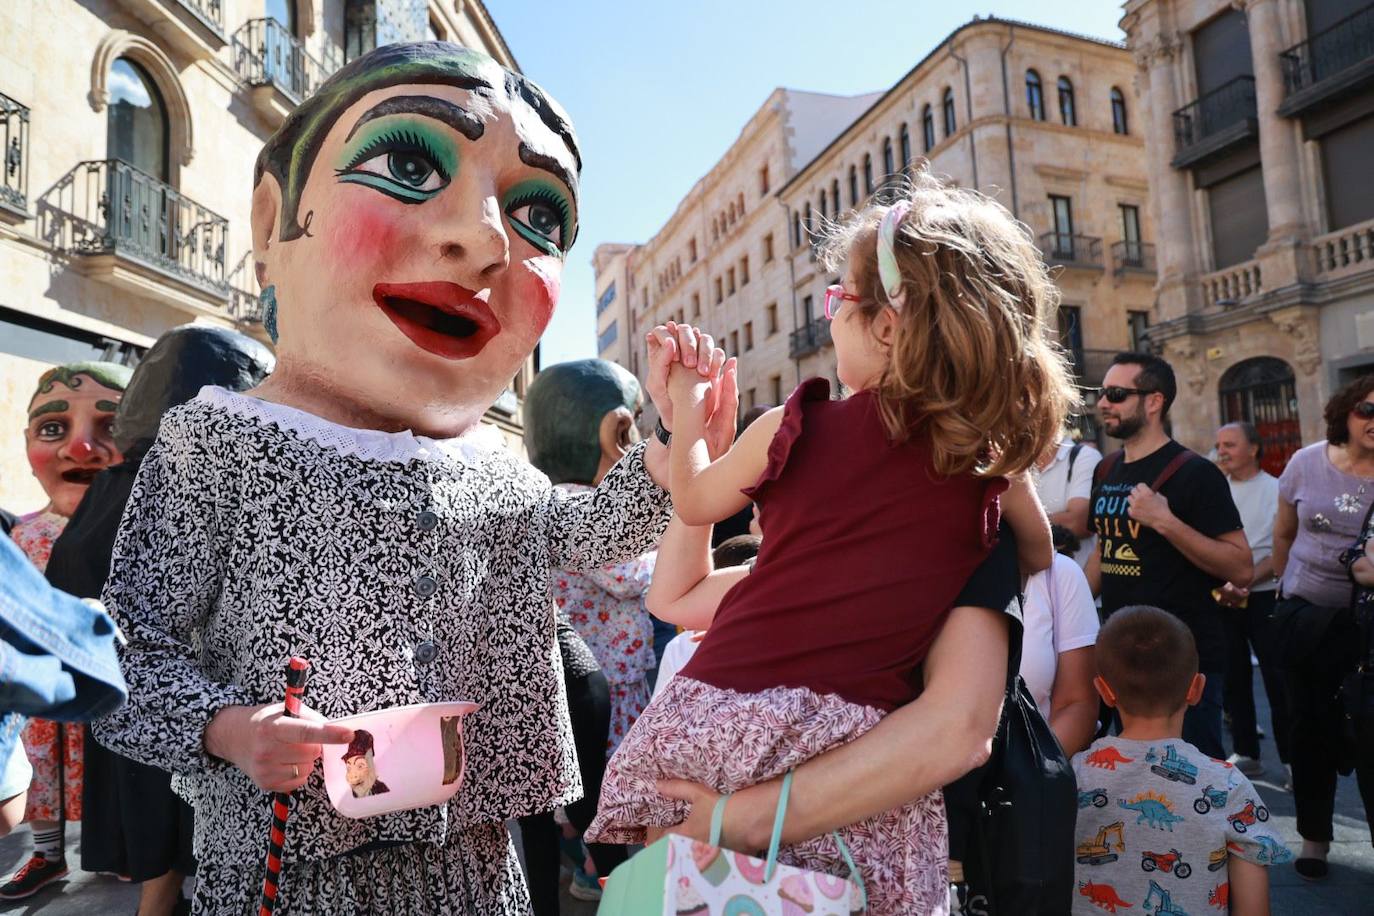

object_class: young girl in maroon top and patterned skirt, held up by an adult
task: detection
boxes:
[588,174,1073,915]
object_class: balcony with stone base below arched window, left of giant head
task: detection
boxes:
[40,159,229,316]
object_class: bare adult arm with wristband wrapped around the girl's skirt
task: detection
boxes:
[660,607,1009,850]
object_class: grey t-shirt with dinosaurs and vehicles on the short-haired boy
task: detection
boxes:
[1073,737,1293,916]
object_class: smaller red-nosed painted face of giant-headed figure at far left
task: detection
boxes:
[23,363,132,516]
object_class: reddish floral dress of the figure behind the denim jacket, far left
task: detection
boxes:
[10,509,82,821]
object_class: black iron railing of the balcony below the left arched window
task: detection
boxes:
[44,159,229,297]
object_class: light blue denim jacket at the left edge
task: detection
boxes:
[0,537,128,761]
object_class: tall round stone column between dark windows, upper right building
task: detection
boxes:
[1246,0,1305,240]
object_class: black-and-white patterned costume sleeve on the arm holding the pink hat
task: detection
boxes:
[93,411,253,773]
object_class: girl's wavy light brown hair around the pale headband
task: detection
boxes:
[822,170,1079,475]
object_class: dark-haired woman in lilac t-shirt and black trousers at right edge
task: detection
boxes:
[1274,375,1374,880]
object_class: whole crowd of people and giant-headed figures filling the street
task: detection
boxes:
[0,35,1374,916]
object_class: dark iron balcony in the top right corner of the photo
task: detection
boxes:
[1279,5,1374,117]
